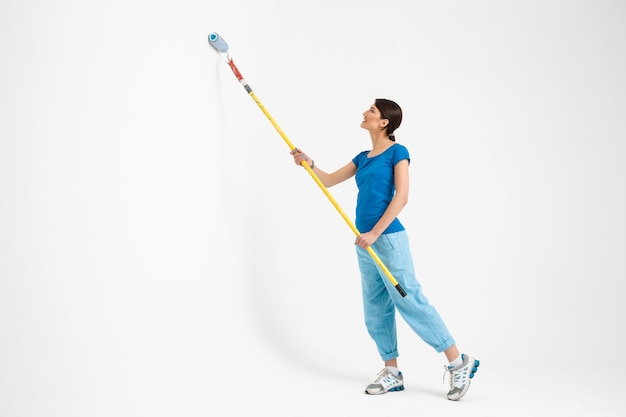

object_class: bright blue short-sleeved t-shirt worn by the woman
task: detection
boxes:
[352,143,411,234]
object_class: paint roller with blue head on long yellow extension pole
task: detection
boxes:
[209,33,406,297]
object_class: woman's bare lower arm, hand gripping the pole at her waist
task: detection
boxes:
[355,159,409,249]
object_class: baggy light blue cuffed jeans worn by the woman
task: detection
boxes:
[356,231,455,361]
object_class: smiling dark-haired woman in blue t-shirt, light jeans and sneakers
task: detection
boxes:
[291,98,479,401]
